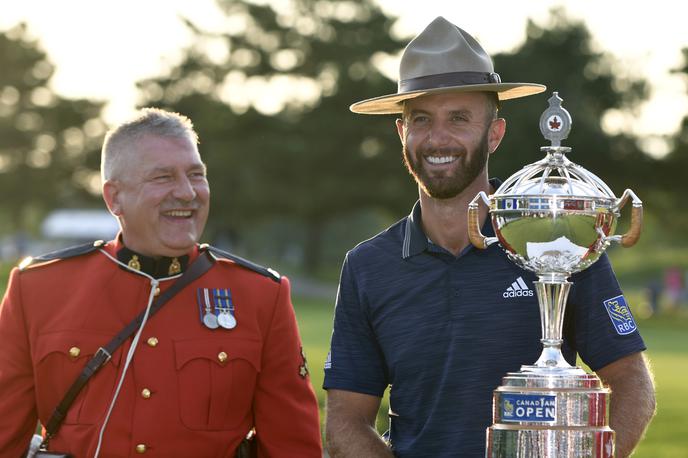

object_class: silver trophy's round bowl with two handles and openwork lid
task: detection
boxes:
[469,147,642,277]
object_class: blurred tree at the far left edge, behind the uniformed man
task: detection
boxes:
[0,24,105,232]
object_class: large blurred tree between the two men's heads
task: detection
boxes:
[140,0,415,271]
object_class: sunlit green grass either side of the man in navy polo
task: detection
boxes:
[294,289,688,458]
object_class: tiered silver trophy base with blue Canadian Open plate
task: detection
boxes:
[485,366,614,458]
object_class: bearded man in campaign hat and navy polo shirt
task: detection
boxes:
[323,17,655,458]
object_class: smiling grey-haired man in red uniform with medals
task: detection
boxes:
[0,109,322,458]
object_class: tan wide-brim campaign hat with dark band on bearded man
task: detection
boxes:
[349,16,547,114]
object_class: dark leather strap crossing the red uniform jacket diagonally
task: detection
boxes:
[44,251,214,445]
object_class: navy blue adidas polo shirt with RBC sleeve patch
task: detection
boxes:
[323,194,645,457]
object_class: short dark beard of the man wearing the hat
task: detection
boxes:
[403,129,490,199]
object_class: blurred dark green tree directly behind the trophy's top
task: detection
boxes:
[491,9,653,191]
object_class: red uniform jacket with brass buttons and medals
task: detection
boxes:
[0,242,322,458]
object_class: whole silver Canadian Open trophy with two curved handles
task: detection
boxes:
[468,92,643,458]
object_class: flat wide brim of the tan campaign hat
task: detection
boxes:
[349,83,547,114]
